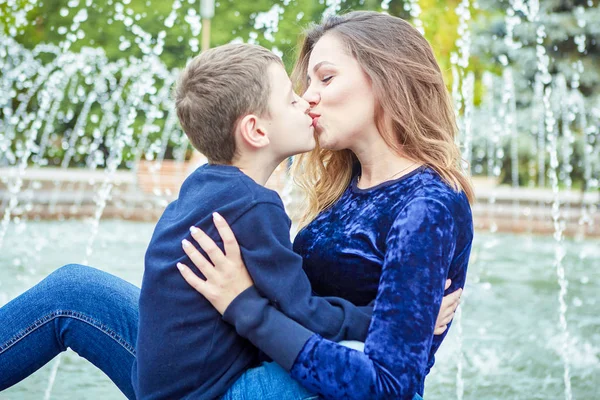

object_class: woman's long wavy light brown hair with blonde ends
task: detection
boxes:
[292,11,475,226]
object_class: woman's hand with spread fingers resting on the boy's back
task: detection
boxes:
[177,213,254,315]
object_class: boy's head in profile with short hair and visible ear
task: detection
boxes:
[175,44,315,164]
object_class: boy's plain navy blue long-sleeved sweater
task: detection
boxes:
[132,165,372,399]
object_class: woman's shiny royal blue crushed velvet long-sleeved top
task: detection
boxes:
[224,167,473,400]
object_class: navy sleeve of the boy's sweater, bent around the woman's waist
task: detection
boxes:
[226,203,372,342]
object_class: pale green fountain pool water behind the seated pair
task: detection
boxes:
[0,221,600,400]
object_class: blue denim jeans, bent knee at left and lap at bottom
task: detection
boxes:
[0,264,421,400]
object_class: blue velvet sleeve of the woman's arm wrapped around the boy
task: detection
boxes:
[223,198,456,399]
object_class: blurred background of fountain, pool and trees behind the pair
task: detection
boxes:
[0,0,600,399]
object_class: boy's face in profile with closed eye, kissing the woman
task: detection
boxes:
[265,63,316,160]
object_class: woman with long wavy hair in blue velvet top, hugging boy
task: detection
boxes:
[179,12,473,399]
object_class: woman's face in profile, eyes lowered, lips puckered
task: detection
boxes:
[302,34,377,150]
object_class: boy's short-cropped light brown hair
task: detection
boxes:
[175,44,282,164]
